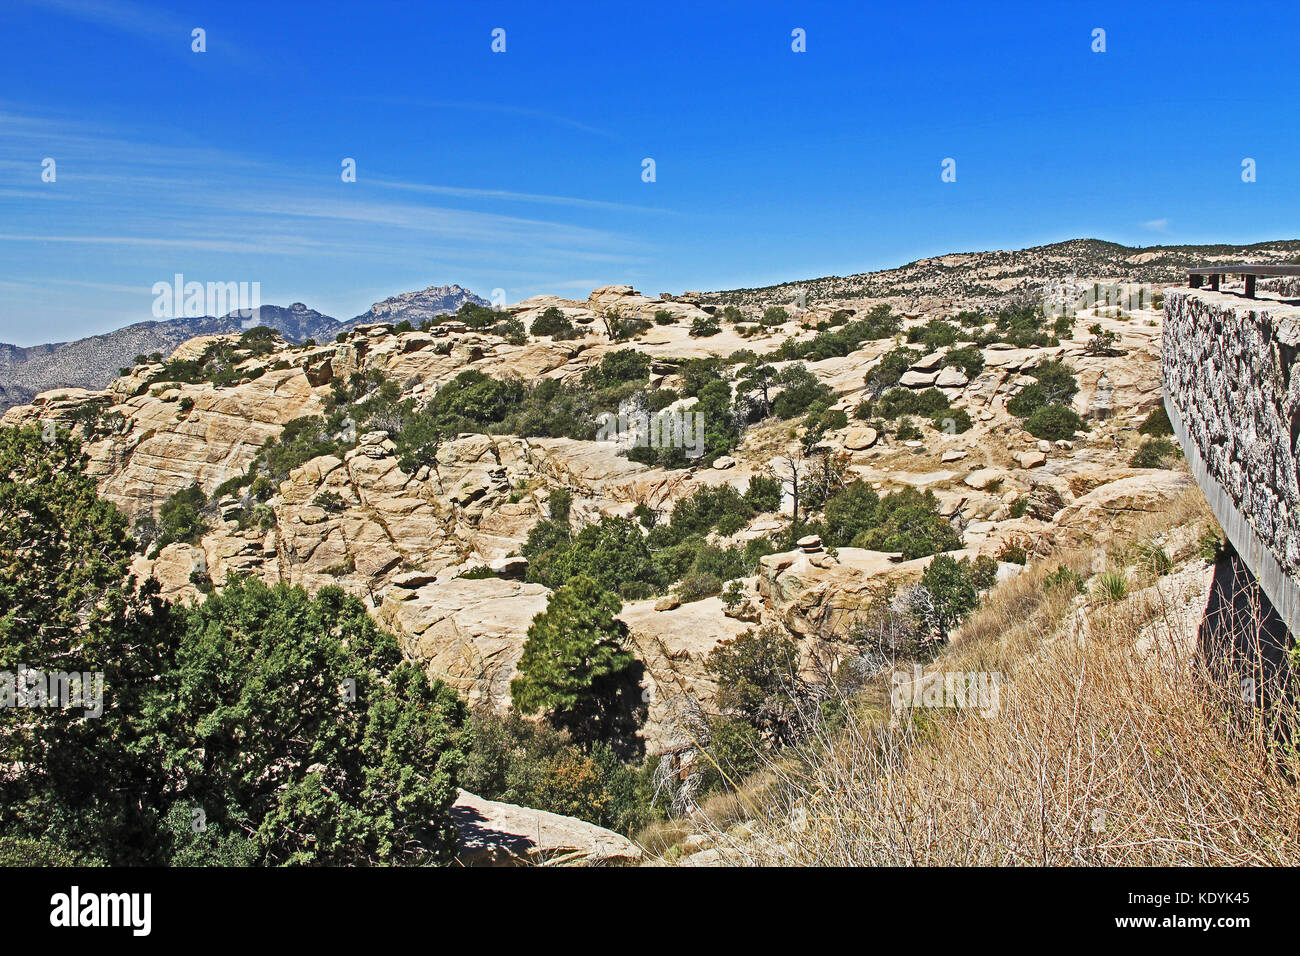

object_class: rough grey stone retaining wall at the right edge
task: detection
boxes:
[1161,289,1300,635]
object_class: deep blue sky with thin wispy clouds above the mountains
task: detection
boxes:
[0,0,1300,345]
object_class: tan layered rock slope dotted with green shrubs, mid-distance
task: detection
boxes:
[4,265,1206,752]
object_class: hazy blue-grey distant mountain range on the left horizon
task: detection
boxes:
[0,285,489,411]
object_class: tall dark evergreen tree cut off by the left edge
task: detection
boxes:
[0,428,173,864]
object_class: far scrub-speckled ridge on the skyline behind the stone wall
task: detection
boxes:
[705,239,1300,304]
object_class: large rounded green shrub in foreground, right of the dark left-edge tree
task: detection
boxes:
[157,579,463,865]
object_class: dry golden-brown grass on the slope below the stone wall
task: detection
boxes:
[670,486,1300,866]
